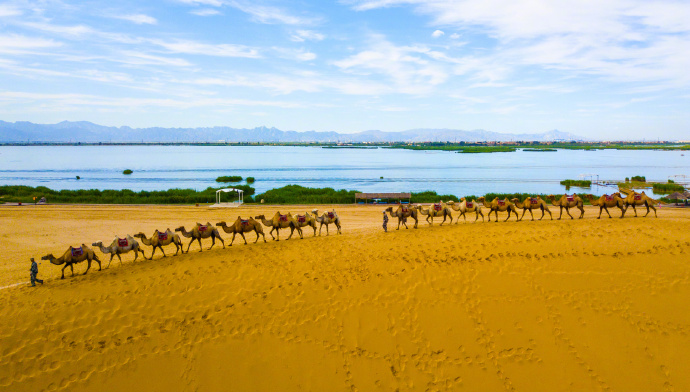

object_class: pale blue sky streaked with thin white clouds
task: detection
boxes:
[0,0,690,140]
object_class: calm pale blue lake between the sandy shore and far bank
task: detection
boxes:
[0,146,690,195]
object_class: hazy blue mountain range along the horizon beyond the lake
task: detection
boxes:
[0,121,586,143]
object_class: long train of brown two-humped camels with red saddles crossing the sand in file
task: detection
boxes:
[41,191,659,279]
